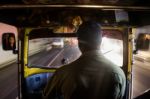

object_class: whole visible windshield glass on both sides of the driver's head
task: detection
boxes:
[28,31,123,68]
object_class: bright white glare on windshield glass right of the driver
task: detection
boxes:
[101,37,123,66]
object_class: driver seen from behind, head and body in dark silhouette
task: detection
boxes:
[44,21,126,99]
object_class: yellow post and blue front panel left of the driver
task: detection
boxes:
[20,28,56,99]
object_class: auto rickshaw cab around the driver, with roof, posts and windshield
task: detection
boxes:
[0,0,150,99]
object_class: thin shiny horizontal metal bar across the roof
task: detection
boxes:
[0,5,150,10]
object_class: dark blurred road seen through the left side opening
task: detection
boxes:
[0,63,17,99]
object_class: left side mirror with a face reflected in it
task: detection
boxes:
[2,33,16,50]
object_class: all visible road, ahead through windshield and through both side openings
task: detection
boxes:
[0,47,150,99]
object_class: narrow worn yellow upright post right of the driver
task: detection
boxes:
[123,27,132,99]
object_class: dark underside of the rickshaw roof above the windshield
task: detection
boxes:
[0,0,150,27]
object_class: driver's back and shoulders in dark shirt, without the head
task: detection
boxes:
[44,51,125,99]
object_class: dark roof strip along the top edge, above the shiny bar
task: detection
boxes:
[0,0,150,6]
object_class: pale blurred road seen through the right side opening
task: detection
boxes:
[133,61,150,97]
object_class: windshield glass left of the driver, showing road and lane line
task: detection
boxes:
[29,37,81,68]
